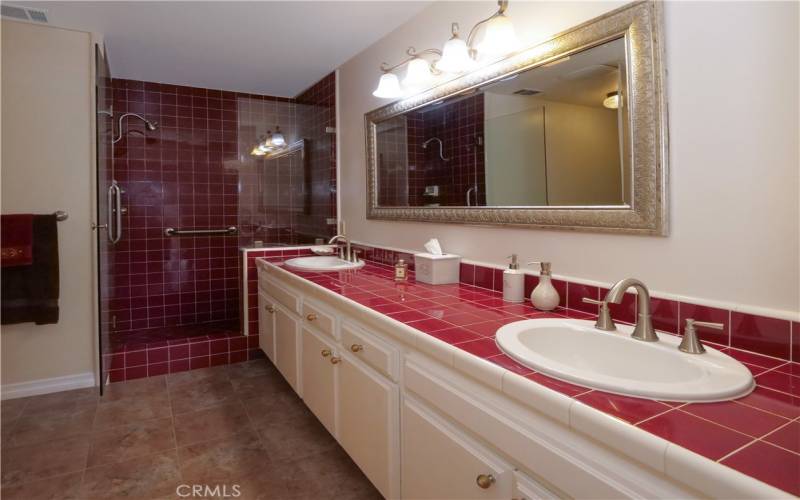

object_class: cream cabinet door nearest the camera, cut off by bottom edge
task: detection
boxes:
[401,397,513,500]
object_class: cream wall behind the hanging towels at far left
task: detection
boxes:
[0,20,96,390]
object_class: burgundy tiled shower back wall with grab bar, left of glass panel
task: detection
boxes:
[109,79,239,332]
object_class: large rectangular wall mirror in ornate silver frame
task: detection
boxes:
[366,2,667,235]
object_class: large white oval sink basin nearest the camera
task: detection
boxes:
[497,319,755,402]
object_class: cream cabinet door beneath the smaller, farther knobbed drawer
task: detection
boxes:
[301,328,339,436]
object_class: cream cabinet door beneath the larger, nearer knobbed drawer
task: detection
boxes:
[338,355,400,498]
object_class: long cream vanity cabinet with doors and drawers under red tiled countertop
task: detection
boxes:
[259,262,732,500]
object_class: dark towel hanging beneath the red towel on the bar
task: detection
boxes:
[0,214,59,325]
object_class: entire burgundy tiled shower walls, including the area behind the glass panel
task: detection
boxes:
[104,74,336,332]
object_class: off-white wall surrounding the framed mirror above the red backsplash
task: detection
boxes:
[339,2,800,316]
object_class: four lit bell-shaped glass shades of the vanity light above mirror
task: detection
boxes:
[372,0,518,99]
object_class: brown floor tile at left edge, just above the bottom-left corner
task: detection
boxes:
[0,435,89,487]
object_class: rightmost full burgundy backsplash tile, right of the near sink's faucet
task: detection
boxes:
[731,311,791,360]
